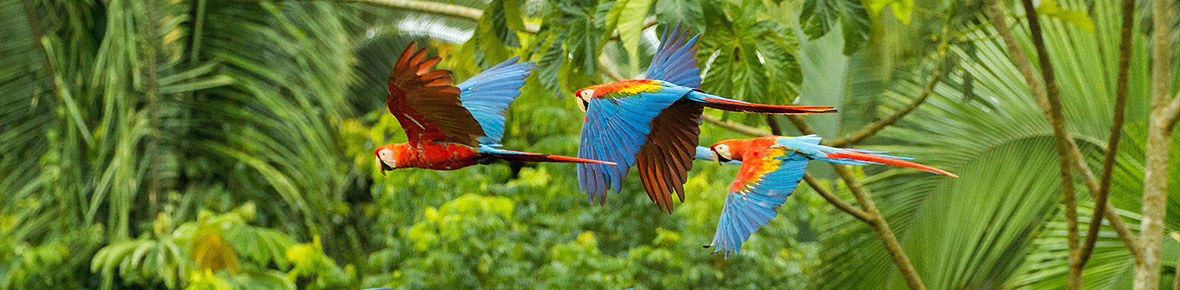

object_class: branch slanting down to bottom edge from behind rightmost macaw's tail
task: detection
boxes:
[787,116,926,290]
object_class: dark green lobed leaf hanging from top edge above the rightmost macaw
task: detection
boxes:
[799,0,870,55]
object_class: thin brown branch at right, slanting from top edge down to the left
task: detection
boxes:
[1076,0,1135,266]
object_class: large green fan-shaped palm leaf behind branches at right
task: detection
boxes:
[819,1,1175,289]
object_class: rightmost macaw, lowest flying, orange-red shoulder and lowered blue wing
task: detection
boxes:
[696,134,958,257]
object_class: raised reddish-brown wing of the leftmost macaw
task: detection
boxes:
[385,42,484,146]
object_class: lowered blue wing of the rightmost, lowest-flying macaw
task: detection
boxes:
[712,149,809,257]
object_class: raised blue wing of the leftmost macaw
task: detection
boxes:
[459,57,537,144]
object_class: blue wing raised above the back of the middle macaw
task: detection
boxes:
[644,25,701,88]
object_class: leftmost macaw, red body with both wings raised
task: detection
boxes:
[373,42,614,174]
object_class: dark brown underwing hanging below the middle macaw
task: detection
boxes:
[636,100,703,213]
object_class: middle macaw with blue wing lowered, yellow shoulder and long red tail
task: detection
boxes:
[576,26,835,213]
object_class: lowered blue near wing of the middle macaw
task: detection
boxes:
[577,86,695,204]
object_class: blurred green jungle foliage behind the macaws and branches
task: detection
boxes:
[0,0,1180,289]
